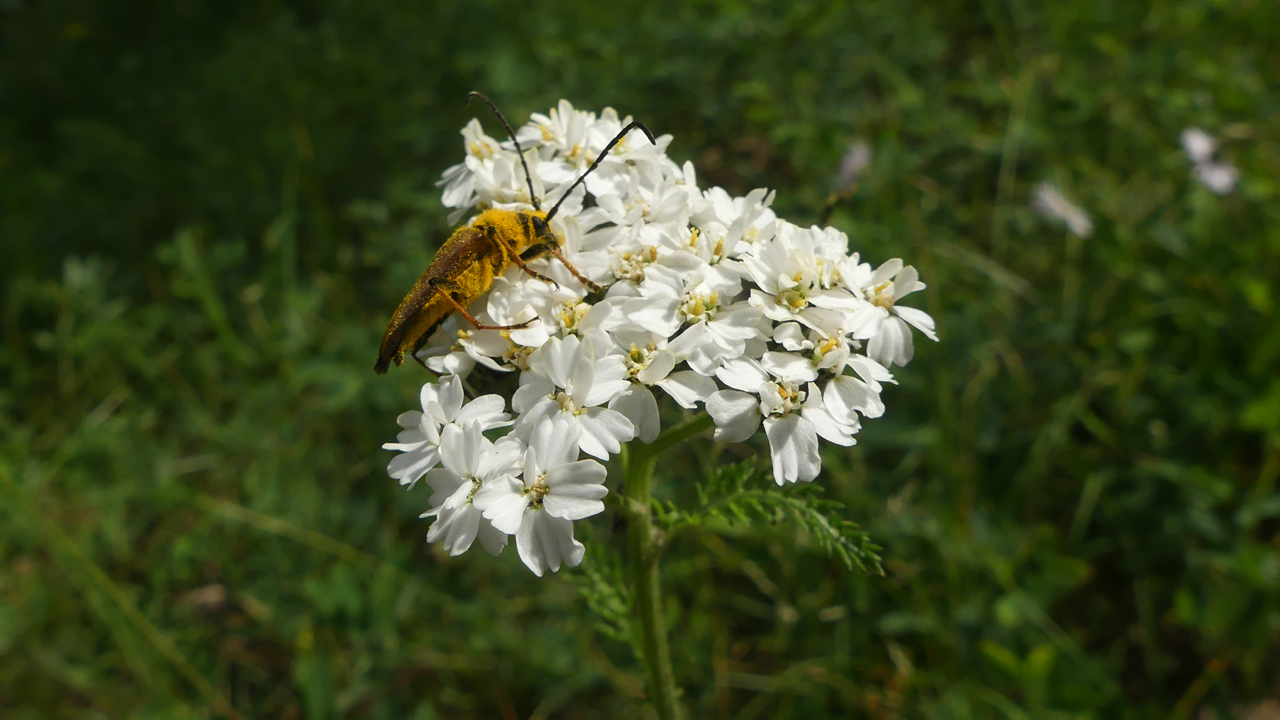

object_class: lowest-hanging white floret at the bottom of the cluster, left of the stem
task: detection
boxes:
[475,419,608,577]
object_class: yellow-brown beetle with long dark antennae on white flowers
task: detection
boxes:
[374,92,655,375]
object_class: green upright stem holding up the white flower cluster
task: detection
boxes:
[622,413,712,720]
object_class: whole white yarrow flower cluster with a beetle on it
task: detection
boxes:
[384,100,937,575]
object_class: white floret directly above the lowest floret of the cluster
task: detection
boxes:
[511,336,636,460]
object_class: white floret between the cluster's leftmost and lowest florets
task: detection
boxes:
[422,423,525,555]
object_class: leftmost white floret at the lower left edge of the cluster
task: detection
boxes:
[383,375,511,488]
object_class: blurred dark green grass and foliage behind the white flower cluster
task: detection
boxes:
[0,0,1280,720]
